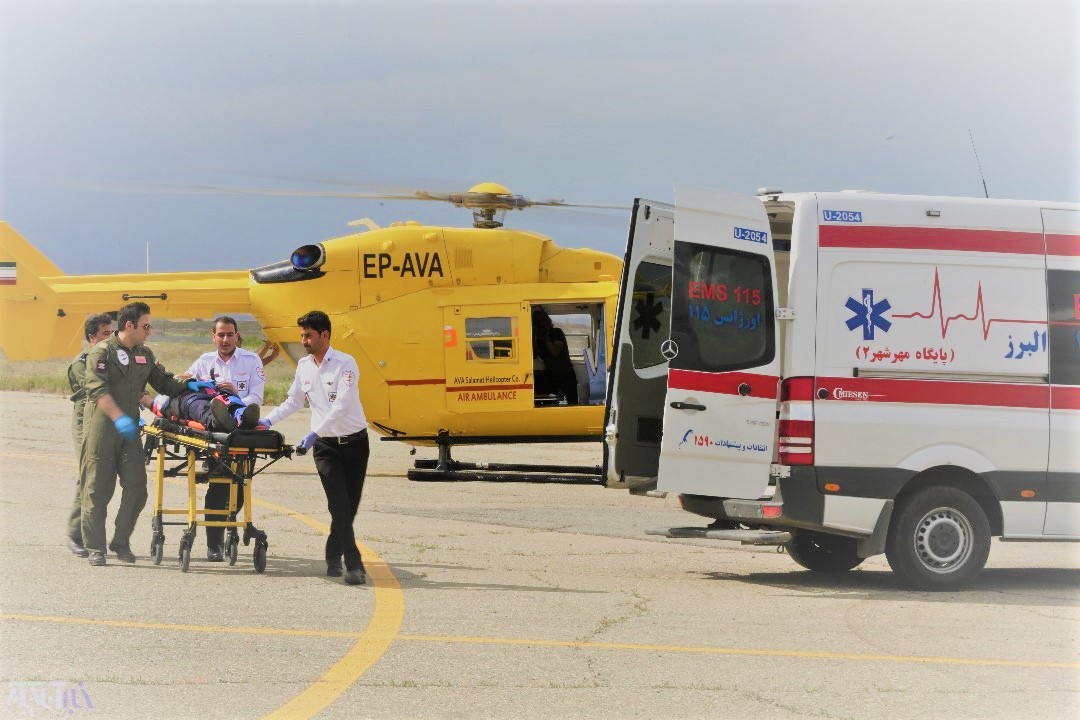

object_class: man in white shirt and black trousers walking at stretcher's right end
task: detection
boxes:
[261,310,368,585]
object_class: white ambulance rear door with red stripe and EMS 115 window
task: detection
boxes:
[658,186,780,499]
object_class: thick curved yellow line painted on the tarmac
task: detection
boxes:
[254,500,405,720]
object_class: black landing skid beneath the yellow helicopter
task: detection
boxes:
[382,433,604,485]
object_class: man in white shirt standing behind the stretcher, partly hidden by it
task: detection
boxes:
[181,315,266,562]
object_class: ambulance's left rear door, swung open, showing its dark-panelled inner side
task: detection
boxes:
[604,199,675,490]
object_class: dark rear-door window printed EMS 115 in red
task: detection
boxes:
[671,243,775,372]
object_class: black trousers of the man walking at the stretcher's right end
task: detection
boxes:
[312,430,369,570]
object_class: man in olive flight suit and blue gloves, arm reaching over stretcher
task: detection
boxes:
[82,302,211,566]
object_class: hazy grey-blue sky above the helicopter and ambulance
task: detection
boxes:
[0,0,1080,274]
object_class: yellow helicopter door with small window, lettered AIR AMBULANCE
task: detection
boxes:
[443,302,532,413]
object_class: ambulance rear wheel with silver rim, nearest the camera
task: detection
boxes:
[886,487,990,590]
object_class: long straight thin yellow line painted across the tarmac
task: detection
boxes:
[0,613,1080,673]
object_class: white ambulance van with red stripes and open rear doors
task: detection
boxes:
[605,187,1080,589]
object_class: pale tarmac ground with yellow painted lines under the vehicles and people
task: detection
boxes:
[0,393,1080,720]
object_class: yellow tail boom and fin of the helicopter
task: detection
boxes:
[0,221,252,359]
